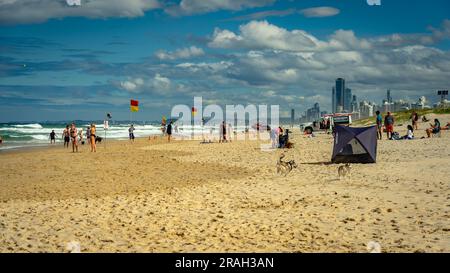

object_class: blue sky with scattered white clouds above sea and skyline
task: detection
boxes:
[0,0,450,122]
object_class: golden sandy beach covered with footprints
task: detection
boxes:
[0,115,450,252]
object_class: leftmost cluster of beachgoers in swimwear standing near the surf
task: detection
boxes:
[59,123,97,153]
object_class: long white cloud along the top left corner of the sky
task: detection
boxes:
[0,0,161,24]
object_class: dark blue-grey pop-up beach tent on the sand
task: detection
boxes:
[331,126,378,164]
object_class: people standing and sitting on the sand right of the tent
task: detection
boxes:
[376,111,442,140]
